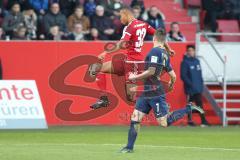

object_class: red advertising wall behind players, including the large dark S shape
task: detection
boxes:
[0,42,218,125]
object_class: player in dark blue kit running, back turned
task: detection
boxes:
[121,29,204,153]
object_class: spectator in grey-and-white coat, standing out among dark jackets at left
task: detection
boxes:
[23,6,37,39]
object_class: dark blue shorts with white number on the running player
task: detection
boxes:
[135,95,169,118]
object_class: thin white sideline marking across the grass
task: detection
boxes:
[0,143,240,152]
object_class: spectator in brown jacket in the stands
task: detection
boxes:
[68,6,90,34]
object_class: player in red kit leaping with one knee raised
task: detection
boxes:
[89,9,174,109]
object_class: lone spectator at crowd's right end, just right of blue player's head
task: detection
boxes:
[167,22,186,42]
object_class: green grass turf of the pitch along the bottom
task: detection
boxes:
[0,126,240,160]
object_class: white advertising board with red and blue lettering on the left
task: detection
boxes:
[0,80,47,129]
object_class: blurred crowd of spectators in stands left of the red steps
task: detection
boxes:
[0,0,188,41]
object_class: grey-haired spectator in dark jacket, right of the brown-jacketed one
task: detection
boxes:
[91,5,114,40]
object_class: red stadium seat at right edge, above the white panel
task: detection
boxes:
[217,20,240,42]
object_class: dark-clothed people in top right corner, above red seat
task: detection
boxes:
[202,0,240,32]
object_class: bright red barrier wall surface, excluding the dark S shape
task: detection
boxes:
[0,42,219,125]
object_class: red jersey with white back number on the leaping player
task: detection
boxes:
[121,19,155,61]
